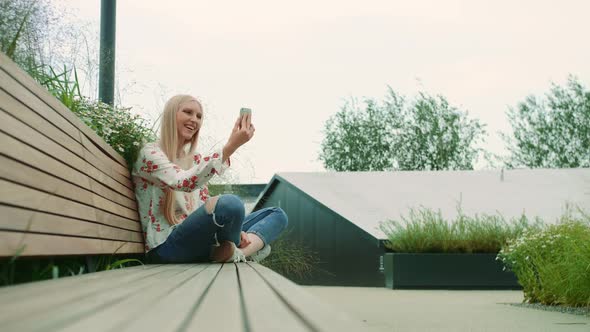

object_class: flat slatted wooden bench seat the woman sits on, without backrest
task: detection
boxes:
[0,263,363,332]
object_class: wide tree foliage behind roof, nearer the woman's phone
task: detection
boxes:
[320,88,485,171]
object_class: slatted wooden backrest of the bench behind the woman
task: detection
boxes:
[0,53,144,257]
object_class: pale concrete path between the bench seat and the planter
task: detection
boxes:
[305,286,590,332]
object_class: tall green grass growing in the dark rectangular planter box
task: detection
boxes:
[380,208,541,253]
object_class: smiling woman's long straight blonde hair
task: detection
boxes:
[160,95,203,225]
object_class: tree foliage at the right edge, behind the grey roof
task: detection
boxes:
[502,76,590,168]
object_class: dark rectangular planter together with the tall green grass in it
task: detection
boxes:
[381,207,542,289]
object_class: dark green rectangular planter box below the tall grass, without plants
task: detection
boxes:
[383,253,521,289]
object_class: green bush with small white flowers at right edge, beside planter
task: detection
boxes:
[498,209,590,306]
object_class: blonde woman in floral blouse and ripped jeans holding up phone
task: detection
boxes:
[132,95,287,263]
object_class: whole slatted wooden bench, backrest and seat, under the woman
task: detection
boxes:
[0,54,362,332]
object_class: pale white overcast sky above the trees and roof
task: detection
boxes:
[58,0,590,183]
